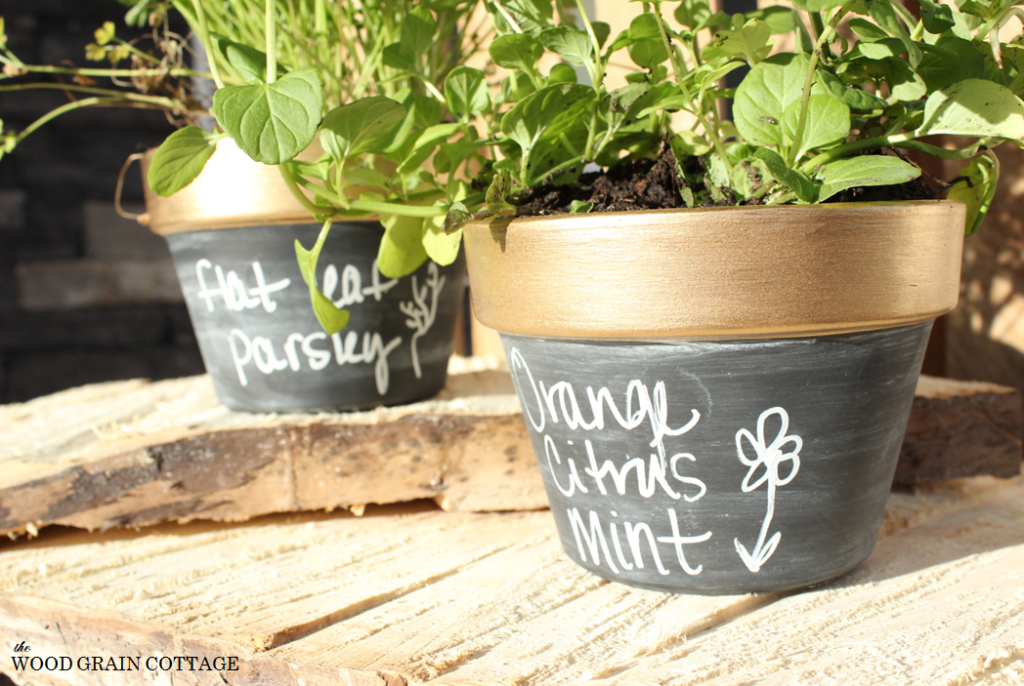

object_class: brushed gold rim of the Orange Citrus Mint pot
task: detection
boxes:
[464,201,966,339]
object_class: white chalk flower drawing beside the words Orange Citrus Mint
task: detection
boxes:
[733,408,804,573]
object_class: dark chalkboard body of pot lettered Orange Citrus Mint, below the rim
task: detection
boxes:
[503,324,931,594]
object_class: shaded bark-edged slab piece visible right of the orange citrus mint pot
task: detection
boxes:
[895,376,1024,484]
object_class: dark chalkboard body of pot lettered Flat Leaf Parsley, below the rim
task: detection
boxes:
[167,222,465,412]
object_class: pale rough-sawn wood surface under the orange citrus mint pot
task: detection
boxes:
[0,477,1024,686]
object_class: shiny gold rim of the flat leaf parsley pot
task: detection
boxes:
[142,138,323,235]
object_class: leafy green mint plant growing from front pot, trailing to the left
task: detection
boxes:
[278,0,1024,333]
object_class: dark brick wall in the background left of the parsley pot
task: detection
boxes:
[0,0,203,402]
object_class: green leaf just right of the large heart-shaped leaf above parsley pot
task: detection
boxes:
[321,95,406,161]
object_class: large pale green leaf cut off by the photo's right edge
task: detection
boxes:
[915,79,1024,139]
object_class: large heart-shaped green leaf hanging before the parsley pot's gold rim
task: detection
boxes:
[213,68,324,165]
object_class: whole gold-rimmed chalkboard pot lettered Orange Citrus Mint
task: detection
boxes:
[464,202,964,594]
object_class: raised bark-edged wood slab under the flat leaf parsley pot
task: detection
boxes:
[0,368,1022,533]
